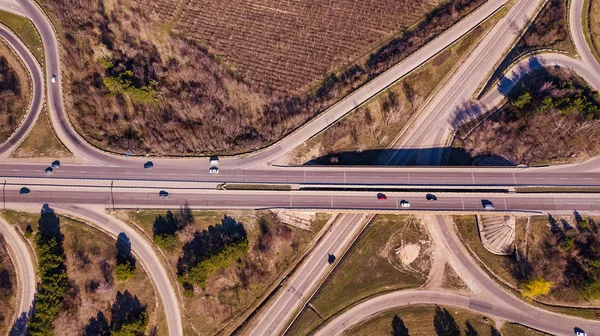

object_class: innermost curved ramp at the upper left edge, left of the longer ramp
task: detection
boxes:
[0,24,44,160]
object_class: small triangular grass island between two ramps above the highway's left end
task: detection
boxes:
[10,107,73,159]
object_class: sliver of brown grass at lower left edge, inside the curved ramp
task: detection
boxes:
[0,232,18,335]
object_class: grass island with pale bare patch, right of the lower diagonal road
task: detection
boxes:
[287,215,432,335]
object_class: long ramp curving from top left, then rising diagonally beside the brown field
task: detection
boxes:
[7,0,507,169]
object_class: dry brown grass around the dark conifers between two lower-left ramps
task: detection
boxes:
[3,211,167,335]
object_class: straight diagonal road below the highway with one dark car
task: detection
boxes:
[250,214,367,336]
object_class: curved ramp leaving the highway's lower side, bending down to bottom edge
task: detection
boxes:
[6,203,183,336]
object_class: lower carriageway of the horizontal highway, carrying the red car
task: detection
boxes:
[2,186,600,212]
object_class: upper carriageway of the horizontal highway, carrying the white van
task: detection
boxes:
[0,163,600,187]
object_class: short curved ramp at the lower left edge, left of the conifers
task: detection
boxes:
[0,217,37,335]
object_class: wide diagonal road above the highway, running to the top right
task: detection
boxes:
[379,0,543,165]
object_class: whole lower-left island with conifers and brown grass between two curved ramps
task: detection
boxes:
[3,209,167,335]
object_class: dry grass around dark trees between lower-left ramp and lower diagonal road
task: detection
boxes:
[117,211,329,335]
